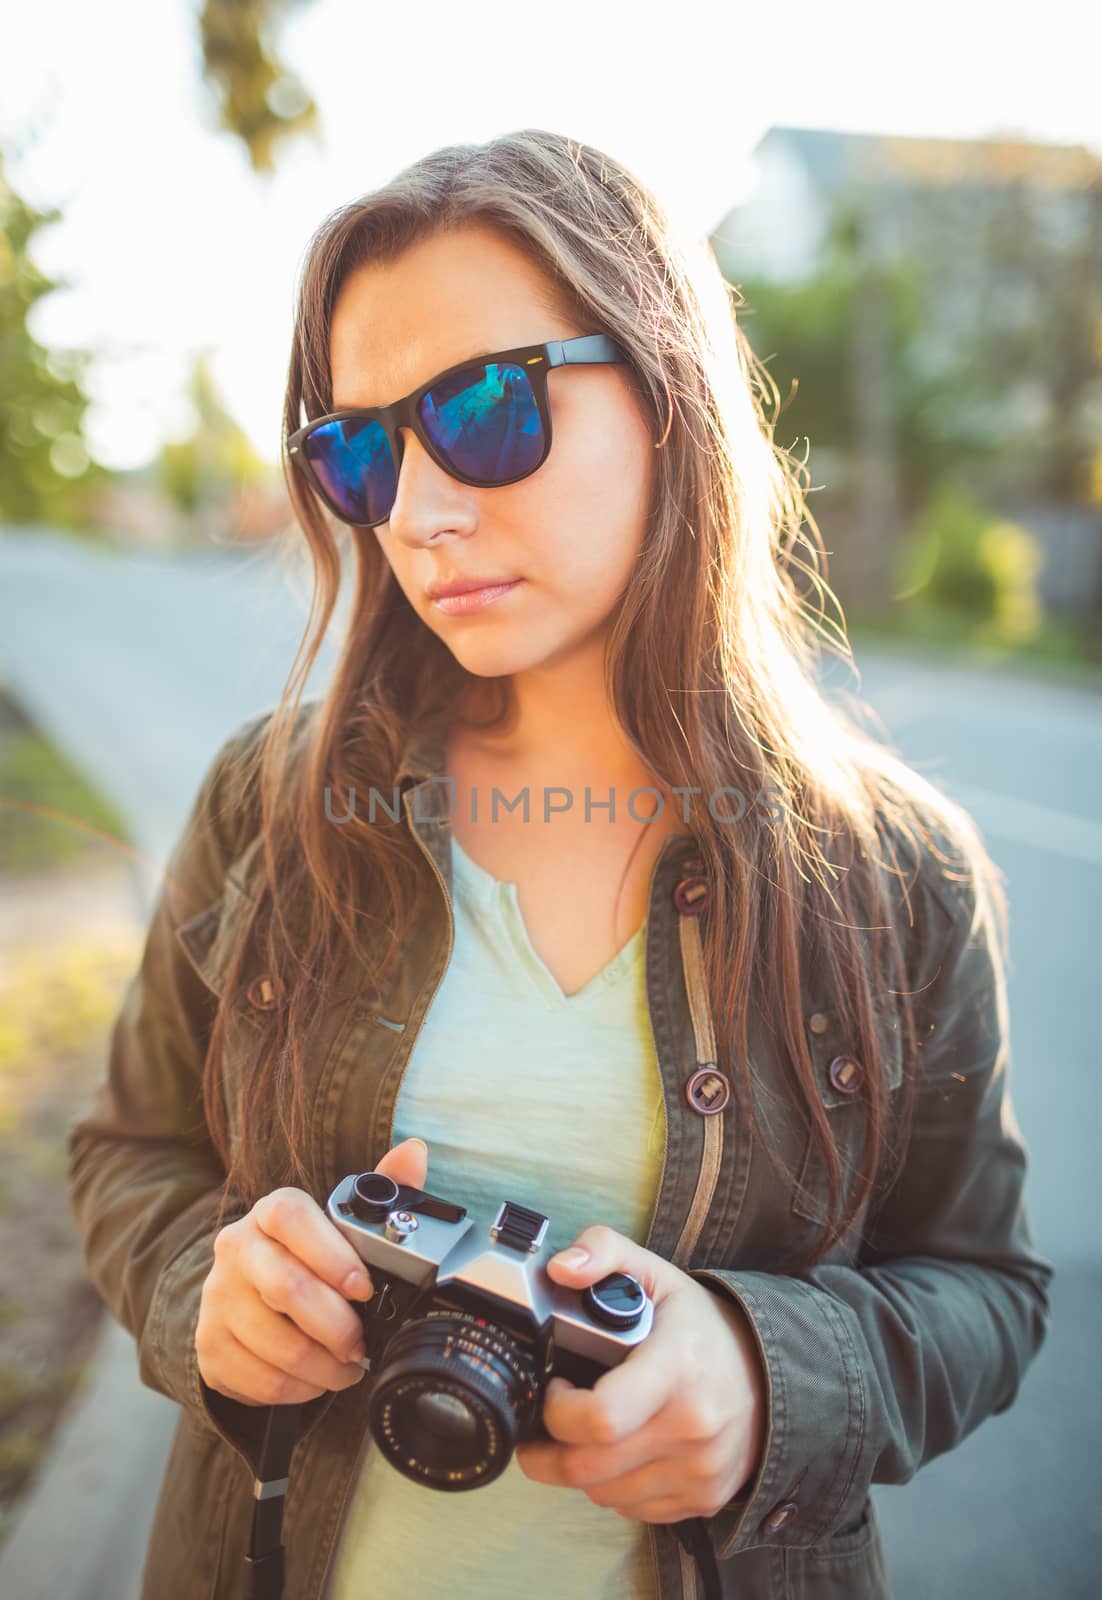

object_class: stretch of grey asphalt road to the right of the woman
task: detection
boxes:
[818,650,1102,1600]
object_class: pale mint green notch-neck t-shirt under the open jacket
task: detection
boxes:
[329,837,665,1600]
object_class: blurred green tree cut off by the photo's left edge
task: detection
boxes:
[0,150,110,534]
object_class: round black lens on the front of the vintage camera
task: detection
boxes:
[368,1310,539,1490]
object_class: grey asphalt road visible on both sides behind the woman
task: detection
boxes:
[0,536,1102,1600]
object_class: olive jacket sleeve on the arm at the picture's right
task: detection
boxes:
[689,819,1052,1558]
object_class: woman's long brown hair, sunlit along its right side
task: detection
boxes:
[203,128,1004,1264]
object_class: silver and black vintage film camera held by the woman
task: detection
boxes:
[326,1173,654,1491]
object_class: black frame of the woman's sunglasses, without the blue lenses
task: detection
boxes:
[286,333,629,528]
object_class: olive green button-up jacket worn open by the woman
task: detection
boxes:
[69,701,1052,1600]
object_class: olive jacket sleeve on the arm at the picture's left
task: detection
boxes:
[67,718,333,1459]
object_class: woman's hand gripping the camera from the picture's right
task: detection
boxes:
[515,1226,768,1522]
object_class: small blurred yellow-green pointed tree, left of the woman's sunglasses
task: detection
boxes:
[157,354,272,542]
